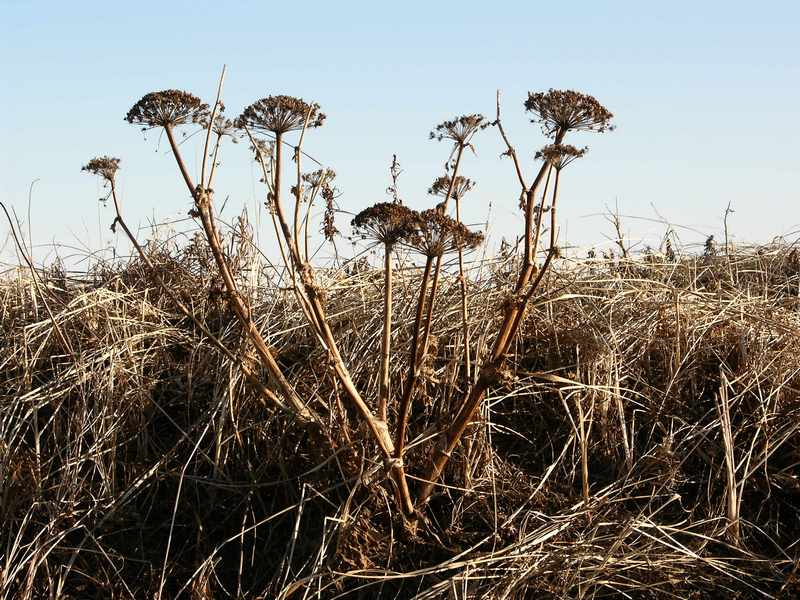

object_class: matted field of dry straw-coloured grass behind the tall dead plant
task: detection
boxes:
[0,237,800,600]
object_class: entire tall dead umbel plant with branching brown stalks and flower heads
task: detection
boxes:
[111,82,612,518]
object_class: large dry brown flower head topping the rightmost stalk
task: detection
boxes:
[525,89,614,135]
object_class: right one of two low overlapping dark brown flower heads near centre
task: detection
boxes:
[404,208,483,258]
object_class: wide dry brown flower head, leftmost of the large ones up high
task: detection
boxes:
[125,90,209,129]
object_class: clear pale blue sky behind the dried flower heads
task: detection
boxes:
[0,0,800,264]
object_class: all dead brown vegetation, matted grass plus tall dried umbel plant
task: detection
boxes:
[0,77,800,600]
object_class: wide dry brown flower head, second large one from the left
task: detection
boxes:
[236,96,325,135]
